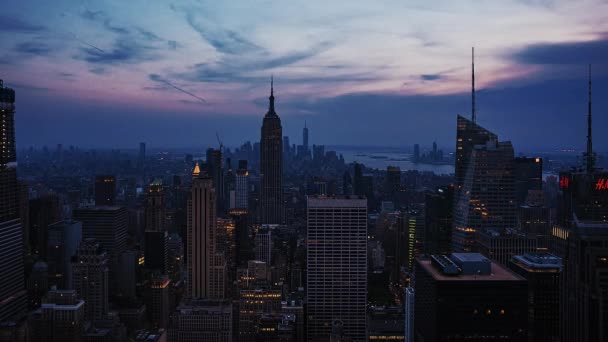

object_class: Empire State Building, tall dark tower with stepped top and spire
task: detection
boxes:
[260,79,284,224]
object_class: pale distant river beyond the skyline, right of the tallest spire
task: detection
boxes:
[326,146,454,175]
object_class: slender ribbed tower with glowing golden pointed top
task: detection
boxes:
[187,164,226,299]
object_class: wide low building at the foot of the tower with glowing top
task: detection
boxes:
[167,300,233,342]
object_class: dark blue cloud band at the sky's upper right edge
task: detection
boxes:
[511,38,608,65]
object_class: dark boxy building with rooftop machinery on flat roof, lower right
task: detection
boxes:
[414,253,528,342]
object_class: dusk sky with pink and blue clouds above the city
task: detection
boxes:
[0,1,608,152]
